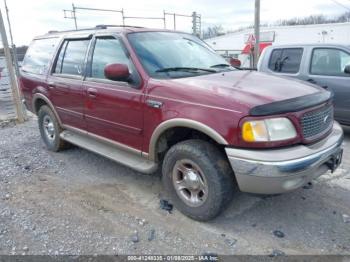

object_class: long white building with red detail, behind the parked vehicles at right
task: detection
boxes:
[205,22,350,67]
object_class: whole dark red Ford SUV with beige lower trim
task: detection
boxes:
[20,26,343,221]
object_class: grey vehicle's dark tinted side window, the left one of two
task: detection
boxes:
[269,48,303,74]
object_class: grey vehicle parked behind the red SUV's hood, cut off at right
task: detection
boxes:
[258,44,350,125]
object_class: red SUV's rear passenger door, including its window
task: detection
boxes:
[48,37,91,130]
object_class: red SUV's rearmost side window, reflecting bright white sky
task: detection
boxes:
[22,38,58,75]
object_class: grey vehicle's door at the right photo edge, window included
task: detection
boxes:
[306,47,350,123]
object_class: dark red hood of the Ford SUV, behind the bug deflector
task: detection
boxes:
[171,70,326,111]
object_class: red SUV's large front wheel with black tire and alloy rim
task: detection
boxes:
[162,140,235,221]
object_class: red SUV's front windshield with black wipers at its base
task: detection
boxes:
[128,32,233,78]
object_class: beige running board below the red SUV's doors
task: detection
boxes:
[60,130,157,174]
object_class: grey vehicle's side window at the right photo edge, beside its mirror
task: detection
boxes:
[310,48,350,76]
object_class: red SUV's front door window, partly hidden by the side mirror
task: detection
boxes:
[91,37,133,79]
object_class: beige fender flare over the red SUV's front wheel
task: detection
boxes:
[148,118,228,161]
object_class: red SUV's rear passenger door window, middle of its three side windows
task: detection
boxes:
[54,39,90,76]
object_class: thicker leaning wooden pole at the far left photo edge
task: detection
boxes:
[0,10,25,123]
